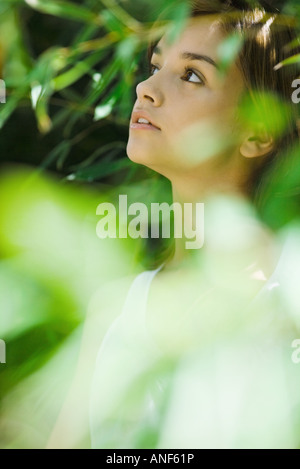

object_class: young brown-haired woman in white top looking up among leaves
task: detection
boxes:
[48,0,299,448]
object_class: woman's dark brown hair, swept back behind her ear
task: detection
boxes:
[148,0,300,204]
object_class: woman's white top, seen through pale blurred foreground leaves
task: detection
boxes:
[90,238,300,449]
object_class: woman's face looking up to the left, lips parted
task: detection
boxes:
[127,17,244,181]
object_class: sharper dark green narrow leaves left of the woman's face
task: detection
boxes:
[0,0,186,184]
